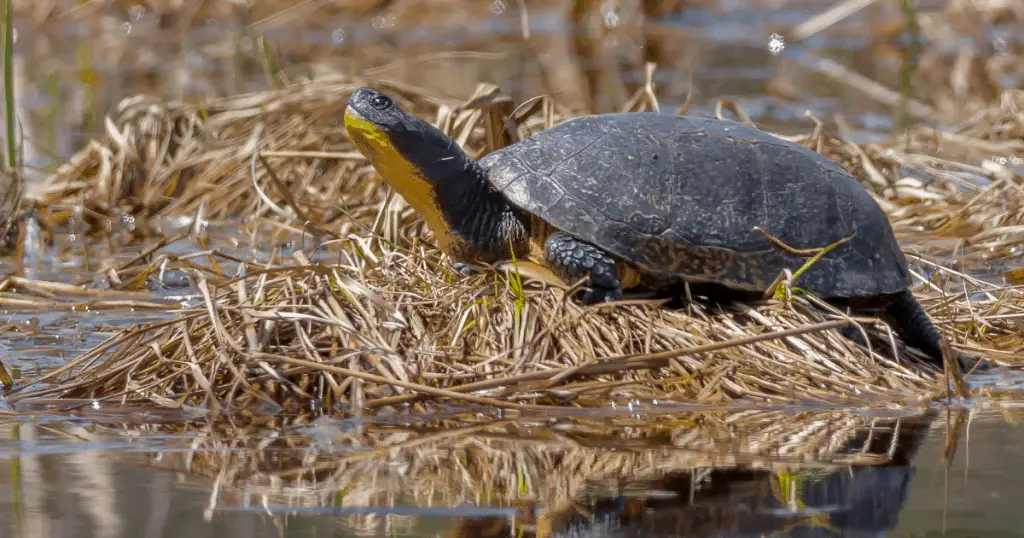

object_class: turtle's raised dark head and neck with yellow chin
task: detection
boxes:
[345,88,479,252]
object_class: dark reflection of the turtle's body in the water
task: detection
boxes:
[452,409,931,538]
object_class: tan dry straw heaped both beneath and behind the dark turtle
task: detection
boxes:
[9,63,1024,414]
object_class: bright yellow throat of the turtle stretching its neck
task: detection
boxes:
[345,107,462,255]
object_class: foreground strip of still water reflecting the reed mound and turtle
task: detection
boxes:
[0,409,1024,538]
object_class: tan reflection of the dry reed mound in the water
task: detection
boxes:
[110,410,937,536]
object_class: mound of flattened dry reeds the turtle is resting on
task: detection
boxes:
[11,218,1024,415]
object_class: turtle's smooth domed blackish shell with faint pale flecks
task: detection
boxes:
[480,113,910,298]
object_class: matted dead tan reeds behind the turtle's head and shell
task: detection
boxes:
[27,66,1024,267]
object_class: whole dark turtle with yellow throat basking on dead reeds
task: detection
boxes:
[344,87,943,368]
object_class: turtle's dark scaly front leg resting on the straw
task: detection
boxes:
[544,232,623,304]
